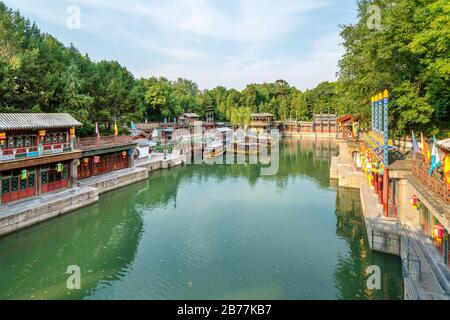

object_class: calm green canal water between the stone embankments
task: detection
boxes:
[0,140,403,299]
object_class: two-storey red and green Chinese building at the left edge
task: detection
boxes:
[0,113,81,205]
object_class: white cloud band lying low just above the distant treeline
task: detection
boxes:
[137,32,343,90]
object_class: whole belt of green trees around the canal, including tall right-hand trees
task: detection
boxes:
[0,0,450,135]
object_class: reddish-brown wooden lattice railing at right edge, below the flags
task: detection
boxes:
[413,161,450,204]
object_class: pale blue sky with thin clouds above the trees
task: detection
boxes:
[3,0,357,90]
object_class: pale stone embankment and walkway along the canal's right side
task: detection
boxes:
[330,141,450,300]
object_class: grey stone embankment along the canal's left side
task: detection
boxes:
[0,153,186,237]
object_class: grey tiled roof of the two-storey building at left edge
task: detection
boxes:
[0,113,82,131]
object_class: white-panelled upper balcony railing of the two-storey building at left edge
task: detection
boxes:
[0,143,73,161]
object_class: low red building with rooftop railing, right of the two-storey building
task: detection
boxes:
[76,136,137,179]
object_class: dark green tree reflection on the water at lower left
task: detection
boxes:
[0,182,148,299]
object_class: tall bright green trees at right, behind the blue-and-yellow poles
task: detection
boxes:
[337,0,450,135]
